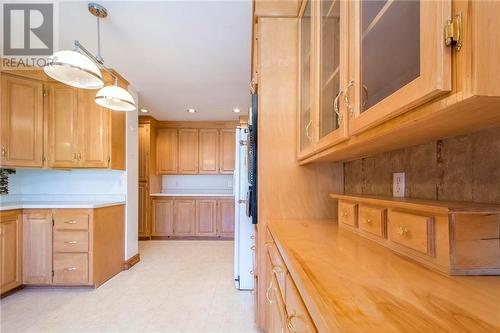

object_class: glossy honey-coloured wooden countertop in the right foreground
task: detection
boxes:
[269,220,500,333]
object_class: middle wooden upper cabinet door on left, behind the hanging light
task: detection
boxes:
[48,83,79,168]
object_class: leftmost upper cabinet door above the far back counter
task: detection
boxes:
[156,128,180,174]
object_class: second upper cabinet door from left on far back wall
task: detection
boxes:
[178,129,198,174]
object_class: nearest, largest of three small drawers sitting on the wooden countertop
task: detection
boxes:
[387,209,434,256]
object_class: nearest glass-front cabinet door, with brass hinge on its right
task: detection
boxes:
[345,0,451,134]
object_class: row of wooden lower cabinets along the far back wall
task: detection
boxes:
[151,196,234,239]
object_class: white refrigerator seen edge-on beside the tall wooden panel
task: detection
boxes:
[233,127,255,290]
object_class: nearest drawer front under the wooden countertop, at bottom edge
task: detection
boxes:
[285,274,317,333]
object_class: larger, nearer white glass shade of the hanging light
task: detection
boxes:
[43,51,104,89]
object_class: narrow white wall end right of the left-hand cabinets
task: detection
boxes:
[125,86,139,260]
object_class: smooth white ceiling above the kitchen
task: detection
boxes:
[58,0,252,120]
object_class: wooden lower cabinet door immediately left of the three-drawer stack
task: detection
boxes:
[23,211,52,284]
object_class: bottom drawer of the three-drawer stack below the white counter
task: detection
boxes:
[53,253,89,285]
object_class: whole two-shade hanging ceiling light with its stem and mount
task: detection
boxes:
[44,3,136,111]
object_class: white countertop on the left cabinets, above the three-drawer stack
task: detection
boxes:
[0,201,125,211]
